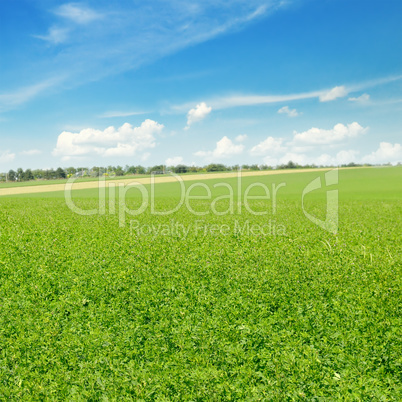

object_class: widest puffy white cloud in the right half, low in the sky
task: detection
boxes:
[293,122,368,145]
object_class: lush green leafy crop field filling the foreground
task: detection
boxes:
[0,167,402,401]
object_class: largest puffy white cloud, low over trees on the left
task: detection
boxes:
[53,119,164,159]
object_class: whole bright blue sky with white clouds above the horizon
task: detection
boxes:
[0,0,402,171]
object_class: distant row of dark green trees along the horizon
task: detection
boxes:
[0,161,378,182]
